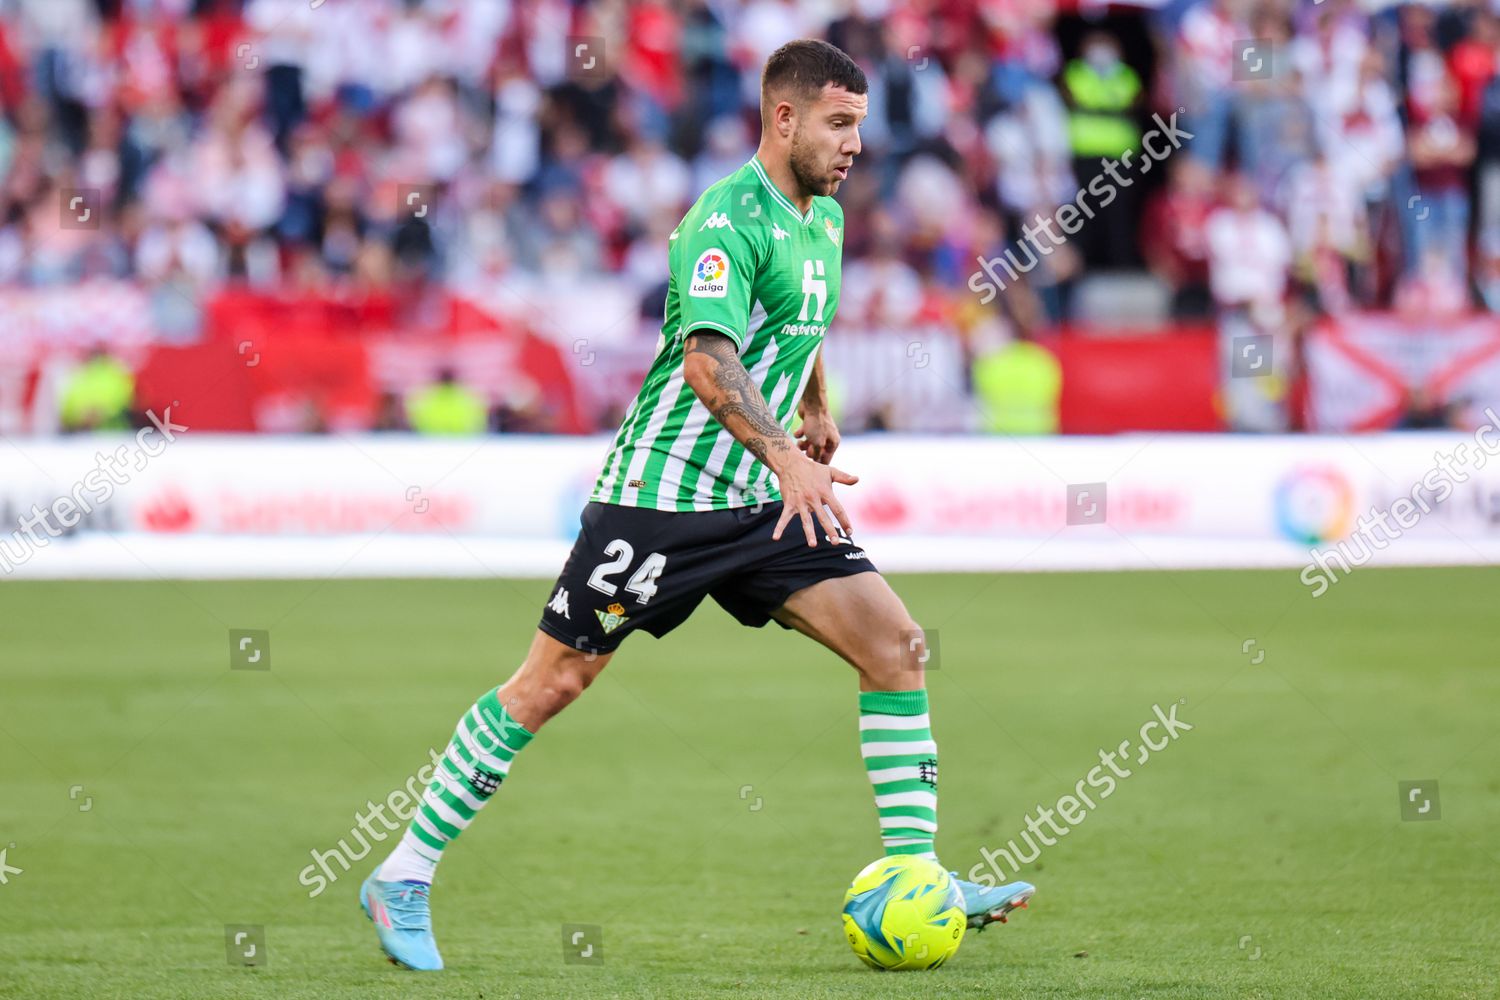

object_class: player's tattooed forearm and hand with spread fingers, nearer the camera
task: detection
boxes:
[683,330,860,546]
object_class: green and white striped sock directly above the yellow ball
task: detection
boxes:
[860,688,938,859]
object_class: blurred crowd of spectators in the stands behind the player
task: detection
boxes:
[0,0,1500,430]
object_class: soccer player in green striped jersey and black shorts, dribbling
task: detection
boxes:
[360,40,1035,970]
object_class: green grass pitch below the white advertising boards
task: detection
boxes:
[0,568,1500,1000]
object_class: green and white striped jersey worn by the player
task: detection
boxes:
[591,159,843,511]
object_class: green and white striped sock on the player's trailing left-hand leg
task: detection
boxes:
[377,688,533,883]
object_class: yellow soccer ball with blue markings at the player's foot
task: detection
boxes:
[843,855,968,970]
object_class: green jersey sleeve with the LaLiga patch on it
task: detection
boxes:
[674,211,759,348]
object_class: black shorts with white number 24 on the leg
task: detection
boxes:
[540,501,875,652]
